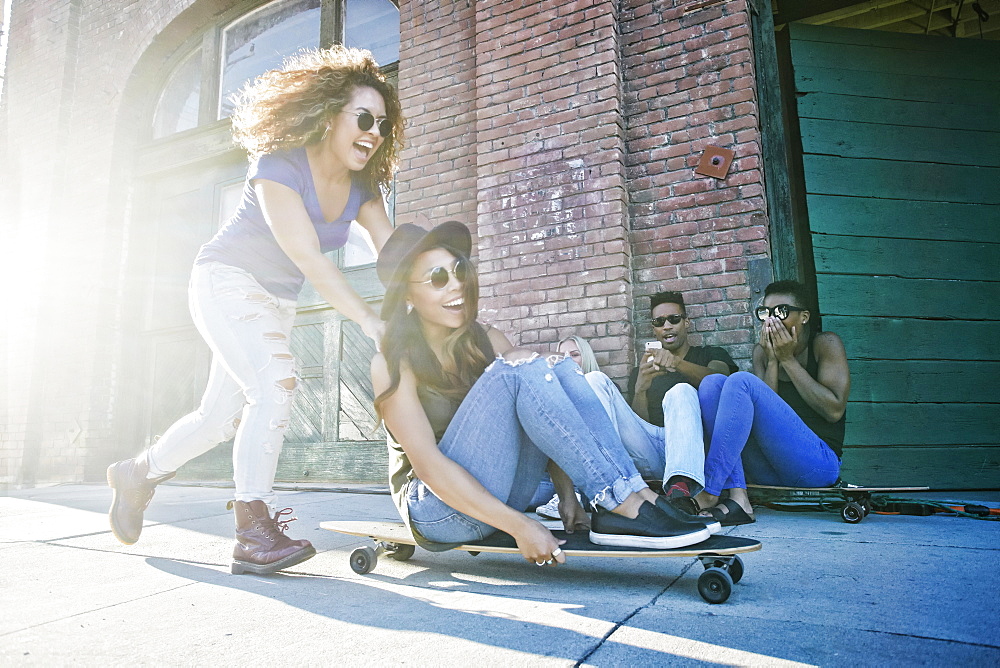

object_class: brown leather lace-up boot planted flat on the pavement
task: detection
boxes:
[230,501,316,575]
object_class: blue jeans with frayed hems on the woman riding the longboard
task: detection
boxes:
[407,357,646,543]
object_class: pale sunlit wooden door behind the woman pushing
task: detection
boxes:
[127,151,388,483]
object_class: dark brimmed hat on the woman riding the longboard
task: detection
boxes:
[375,220,472,319]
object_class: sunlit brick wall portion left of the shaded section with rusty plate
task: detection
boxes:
[397,0,632,377]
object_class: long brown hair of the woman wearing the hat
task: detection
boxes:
[375,246,494,418]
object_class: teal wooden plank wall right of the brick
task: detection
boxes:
[789,24,1000,489]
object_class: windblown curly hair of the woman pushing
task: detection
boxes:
[232,45,403,193]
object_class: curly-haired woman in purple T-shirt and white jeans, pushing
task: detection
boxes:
[108,46,403,574]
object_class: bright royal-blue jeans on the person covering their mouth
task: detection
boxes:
[698,371,840,496]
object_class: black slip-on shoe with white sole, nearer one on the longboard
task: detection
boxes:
[590,501,712,550]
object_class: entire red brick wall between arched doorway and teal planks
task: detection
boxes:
[398,0,767,380]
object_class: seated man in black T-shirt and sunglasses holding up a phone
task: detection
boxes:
[628,292,738,500]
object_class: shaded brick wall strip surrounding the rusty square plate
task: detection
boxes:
[621,0,768,365]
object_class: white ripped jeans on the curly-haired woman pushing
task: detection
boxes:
[147,262,298,504]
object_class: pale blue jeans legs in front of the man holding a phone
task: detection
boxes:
[587,371,705,491]
